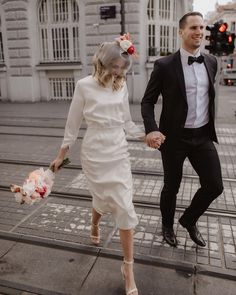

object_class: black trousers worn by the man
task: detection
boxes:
[160,126,223,227]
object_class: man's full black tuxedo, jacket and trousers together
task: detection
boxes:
[141,51,223,227]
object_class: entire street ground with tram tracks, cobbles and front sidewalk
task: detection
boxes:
[0,88,236,295]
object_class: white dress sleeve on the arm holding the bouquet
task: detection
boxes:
[61,81,84,148]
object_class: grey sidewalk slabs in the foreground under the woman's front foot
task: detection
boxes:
[0,240,235,295]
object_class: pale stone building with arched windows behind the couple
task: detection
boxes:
[0,0,193,102]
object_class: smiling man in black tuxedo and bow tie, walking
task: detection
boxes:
[142,12,223,247]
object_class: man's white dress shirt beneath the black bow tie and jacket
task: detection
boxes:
[180,48,209,128]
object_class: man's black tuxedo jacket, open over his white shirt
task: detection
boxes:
[141,50,218,146]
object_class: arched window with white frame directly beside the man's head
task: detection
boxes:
[147,0,178,56]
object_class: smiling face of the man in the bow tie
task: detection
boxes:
[179,15,204,52]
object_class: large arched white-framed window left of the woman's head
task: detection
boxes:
[38,0,79,62]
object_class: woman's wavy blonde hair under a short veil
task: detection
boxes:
[92,41,131,90]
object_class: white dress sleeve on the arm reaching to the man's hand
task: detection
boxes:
[124,85,145,140]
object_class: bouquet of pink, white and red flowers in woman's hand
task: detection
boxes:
[10,158,70,205]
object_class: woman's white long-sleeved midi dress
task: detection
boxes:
[62,76,145,229]
